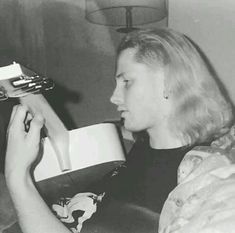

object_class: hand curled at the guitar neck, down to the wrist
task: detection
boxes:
[5,105,44,177]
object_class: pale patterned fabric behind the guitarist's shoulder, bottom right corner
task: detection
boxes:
[159,127,235,233]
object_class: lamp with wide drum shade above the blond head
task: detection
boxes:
[85,0,167,33]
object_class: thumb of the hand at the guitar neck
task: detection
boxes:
[27,114,44,143]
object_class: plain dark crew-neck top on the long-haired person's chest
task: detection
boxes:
[106,136,191,213]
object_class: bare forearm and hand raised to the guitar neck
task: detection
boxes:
[5,105,70,233]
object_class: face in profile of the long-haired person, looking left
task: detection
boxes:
[111,48,170,132]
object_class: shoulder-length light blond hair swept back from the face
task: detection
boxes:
[117,29,233,145]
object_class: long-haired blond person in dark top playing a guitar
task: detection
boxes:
[5,29,233,233]
